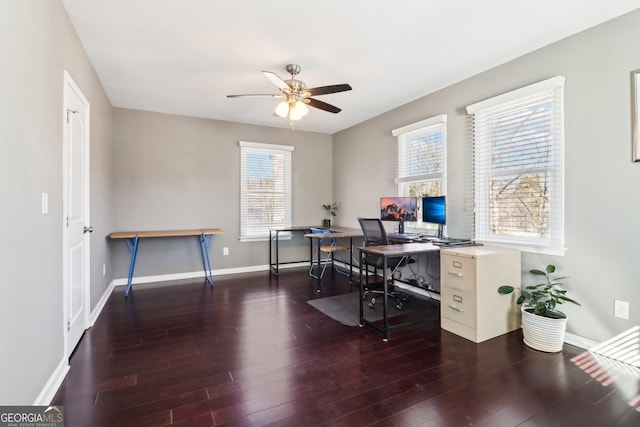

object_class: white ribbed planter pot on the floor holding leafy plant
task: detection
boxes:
[521,306,567,353]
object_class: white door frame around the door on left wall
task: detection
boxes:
[61,70,91,359]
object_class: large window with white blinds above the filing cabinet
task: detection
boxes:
[467,77,564,255]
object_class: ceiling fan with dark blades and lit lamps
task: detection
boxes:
[227,64,351,120]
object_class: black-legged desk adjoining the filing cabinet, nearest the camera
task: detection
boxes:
[358,244,440,341]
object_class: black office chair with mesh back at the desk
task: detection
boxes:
[358,218,410,310]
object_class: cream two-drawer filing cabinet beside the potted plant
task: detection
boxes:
[440,246,521,343]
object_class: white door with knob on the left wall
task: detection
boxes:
[62,71,92,357]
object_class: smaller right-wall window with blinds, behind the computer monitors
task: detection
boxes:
[391,114,447,227]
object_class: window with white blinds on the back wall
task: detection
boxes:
[240,141,293,242]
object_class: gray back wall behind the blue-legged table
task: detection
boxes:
[111,108,332,278]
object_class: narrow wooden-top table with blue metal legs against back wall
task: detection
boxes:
[107,228,223,298]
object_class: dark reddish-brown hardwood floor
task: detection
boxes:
[52,269,640,427]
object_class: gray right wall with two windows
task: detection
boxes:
[333,11,640,341]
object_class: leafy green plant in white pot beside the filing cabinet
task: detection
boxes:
[498,264,580,352]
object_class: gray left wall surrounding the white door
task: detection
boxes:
[0,0,111,405]
